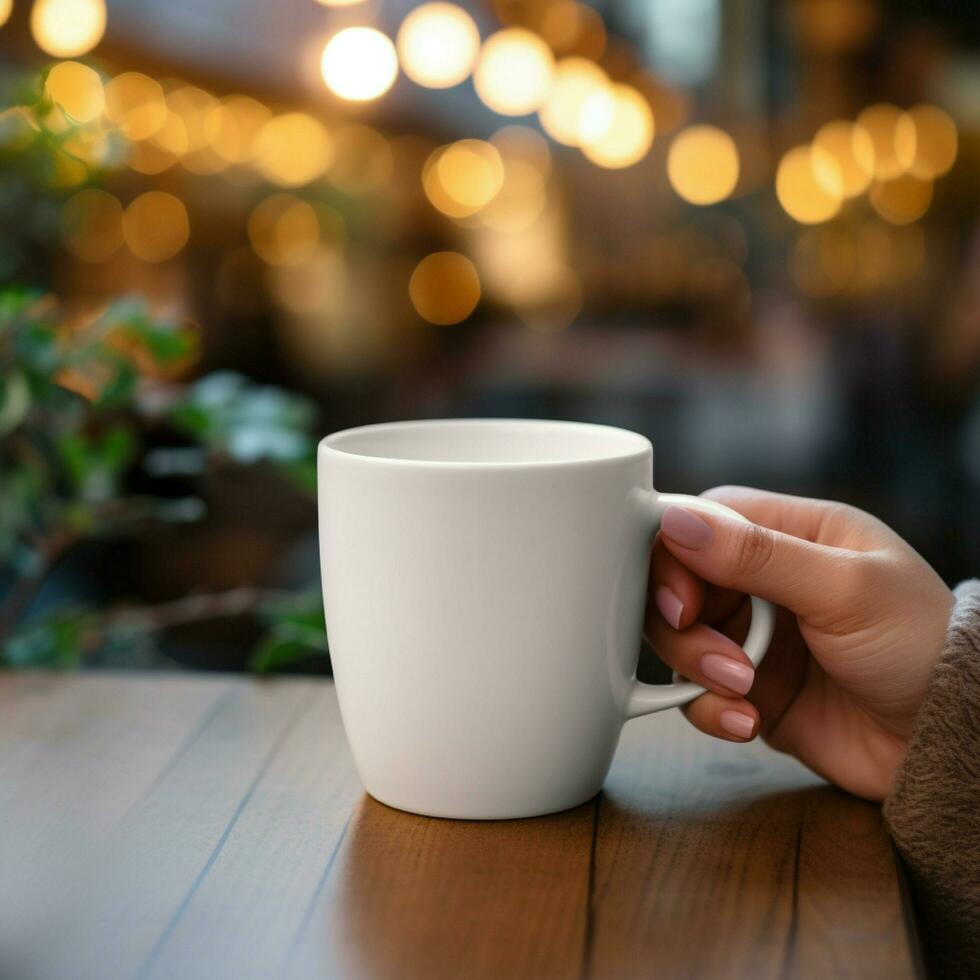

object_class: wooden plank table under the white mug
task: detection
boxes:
[0,674,919,980]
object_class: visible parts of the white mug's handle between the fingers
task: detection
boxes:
[626,490,776,718]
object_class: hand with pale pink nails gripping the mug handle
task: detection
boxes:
[646,487,953,800]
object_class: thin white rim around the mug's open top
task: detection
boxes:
[318,418,653,470]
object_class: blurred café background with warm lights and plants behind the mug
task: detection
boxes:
[0,0,980,671]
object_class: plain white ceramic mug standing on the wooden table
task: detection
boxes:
[319,420,773,819]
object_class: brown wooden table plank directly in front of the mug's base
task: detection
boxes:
[292,798,595,980]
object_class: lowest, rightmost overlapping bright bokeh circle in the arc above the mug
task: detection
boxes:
[579,85,654,169]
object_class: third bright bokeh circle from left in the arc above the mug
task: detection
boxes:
[473,27,555,116]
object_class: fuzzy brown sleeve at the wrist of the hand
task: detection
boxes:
[884,579,980,977]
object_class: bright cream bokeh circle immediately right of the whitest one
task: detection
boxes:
[396,3,480,88]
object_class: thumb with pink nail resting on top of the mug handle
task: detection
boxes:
[660,502,858,617]
